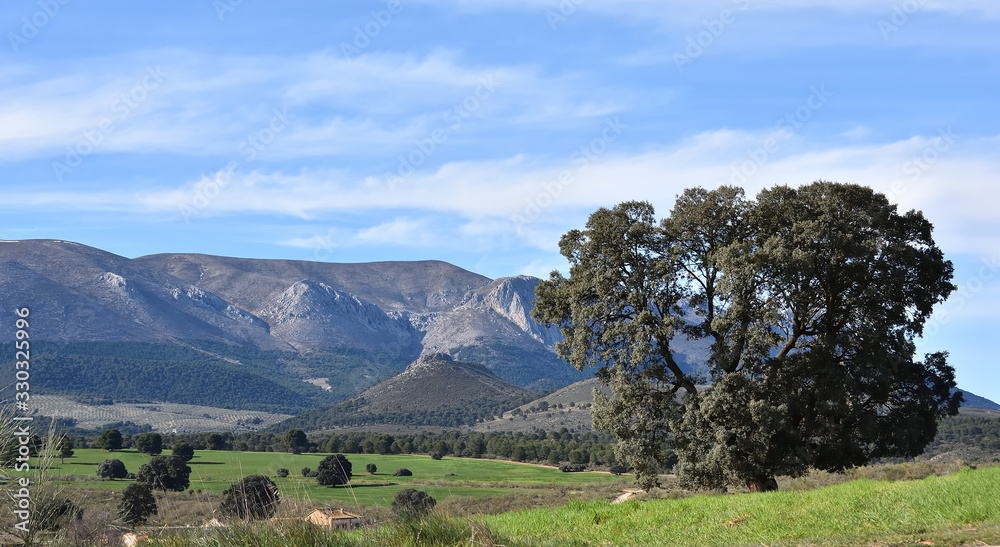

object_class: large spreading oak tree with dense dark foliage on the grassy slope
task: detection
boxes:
[533,182,961,491]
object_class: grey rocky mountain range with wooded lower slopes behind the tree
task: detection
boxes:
[0,240,995,428]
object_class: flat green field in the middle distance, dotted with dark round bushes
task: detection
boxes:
[50,449,629,506]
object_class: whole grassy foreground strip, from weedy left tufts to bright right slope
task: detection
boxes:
[135,467,1000,547]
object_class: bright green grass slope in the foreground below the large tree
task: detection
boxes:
[483,467,1000,546]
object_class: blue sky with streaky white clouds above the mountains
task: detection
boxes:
[0,0,1000,401]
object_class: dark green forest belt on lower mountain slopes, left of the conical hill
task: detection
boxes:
[0,340,409,414]
